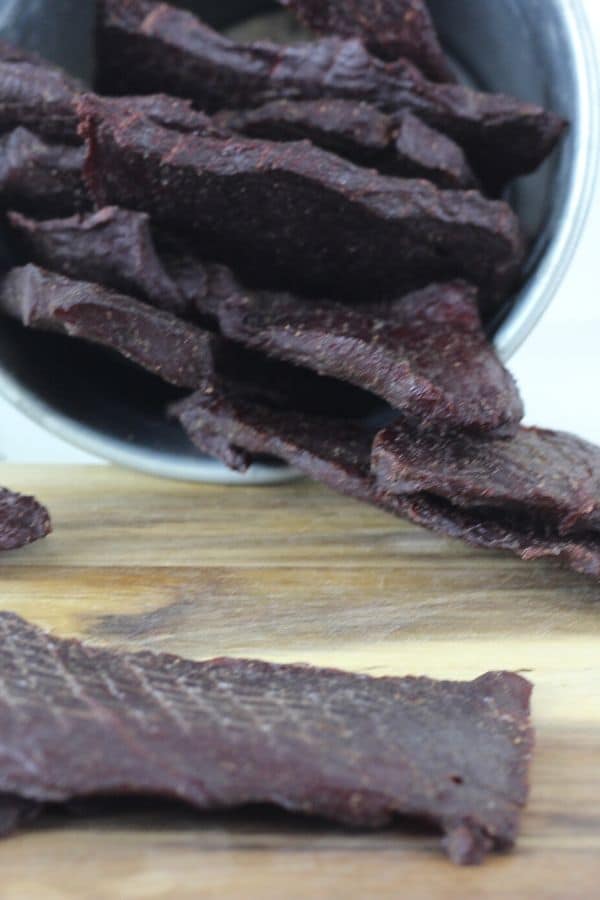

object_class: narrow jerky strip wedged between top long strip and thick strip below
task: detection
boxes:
[214,100,477,189]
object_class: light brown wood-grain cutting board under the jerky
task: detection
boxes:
[0,466,600,900]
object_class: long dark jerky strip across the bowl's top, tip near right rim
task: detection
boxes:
[98,0,566,189]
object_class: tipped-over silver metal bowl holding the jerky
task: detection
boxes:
[0,0,600,484]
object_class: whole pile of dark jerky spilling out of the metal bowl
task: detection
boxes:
[0,0,600,577]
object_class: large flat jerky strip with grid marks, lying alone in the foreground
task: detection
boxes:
[0,613,533,863]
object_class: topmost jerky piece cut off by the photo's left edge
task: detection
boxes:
[0,41,84,144]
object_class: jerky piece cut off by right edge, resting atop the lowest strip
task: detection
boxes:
[373,425,600,537]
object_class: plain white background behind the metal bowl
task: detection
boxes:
[0,0,600,462]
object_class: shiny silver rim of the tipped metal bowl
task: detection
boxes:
[0,0,600,485]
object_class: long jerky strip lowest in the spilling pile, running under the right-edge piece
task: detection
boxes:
[173,383,600,578]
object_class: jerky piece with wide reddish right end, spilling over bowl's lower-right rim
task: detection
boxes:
[219,282,523,433]
